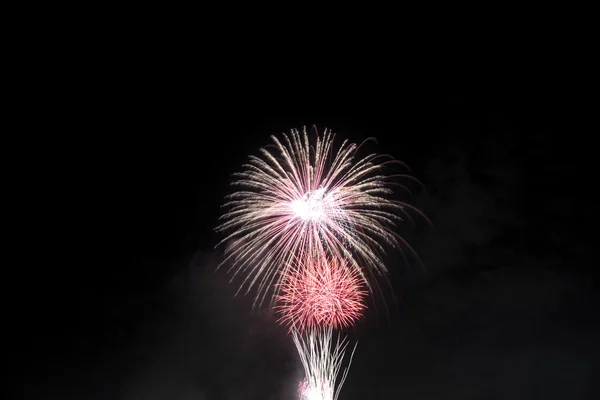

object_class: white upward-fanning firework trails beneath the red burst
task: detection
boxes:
[292,328,356,400]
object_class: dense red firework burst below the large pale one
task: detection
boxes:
[275,258,368,331]
